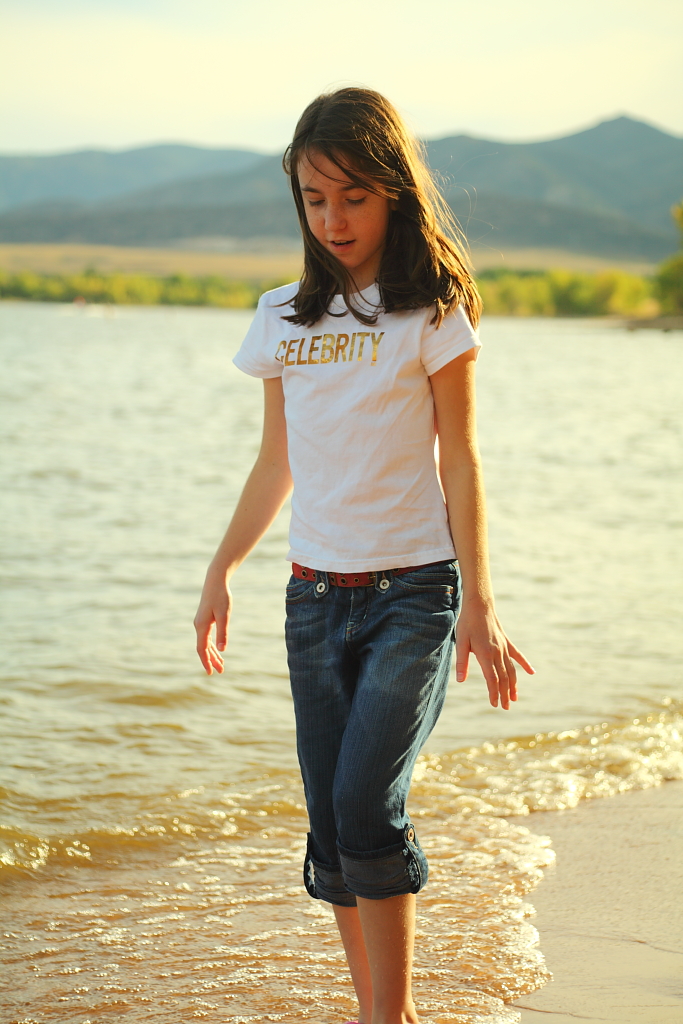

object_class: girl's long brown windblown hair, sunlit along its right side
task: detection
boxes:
[283,88,481,327]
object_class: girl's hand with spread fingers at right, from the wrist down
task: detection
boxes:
[456,601,535,711]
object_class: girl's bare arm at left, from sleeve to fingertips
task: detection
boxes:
[195,377,292,676]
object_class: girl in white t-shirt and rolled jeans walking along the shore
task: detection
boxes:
[195,88,533,1024]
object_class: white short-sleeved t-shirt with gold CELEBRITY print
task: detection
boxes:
[234,284,480,572]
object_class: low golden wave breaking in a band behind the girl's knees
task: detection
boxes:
[0,694,683,874]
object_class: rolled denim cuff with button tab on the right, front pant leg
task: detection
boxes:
[337,824,429,899]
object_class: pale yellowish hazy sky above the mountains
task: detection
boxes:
[0,0,683,153]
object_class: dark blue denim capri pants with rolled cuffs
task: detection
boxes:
[286,561,460,906]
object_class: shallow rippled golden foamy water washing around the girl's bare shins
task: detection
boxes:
[2,783,552,1024]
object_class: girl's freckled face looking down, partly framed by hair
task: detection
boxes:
[297,154,391,291]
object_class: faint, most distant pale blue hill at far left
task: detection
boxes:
[0,145,263,210]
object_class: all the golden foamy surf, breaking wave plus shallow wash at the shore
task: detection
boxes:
[2,701,683,1024]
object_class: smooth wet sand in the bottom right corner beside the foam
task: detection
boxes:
[510,781,683,1024]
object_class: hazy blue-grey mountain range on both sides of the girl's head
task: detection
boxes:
[0,117,683,261]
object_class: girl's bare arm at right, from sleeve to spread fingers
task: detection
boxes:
[430,349,533,711]
